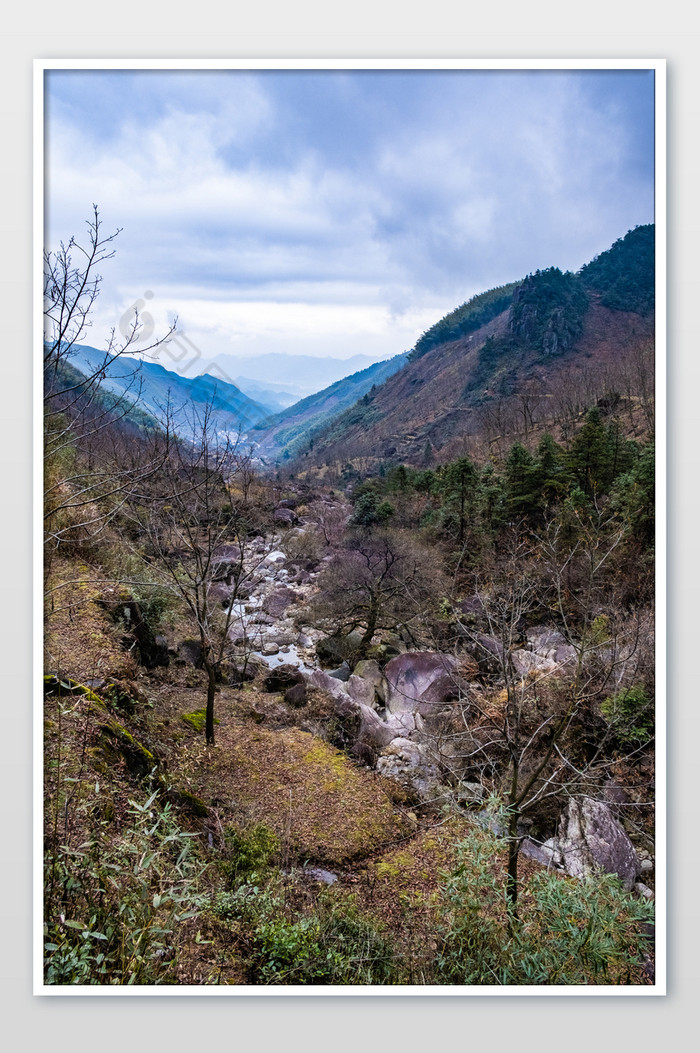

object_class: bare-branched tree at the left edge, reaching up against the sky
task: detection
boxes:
[43,205,175,579]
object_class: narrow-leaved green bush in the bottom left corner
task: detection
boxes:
[44,791,204,985]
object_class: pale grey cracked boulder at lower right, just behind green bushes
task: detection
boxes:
[555,797,641,892]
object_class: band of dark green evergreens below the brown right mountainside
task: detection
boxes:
[353,408,655,550]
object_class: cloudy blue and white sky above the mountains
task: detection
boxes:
[45,69,654,370]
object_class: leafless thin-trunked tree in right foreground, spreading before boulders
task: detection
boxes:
[433,517,649,911]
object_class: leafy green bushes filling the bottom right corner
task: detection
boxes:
[436,834,654,986]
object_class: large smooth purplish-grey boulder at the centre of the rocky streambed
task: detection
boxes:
[384,651,460,716]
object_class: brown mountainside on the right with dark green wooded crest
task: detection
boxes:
[286,224,654,482]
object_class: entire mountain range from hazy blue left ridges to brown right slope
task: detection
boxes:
[62,224,655,472]
